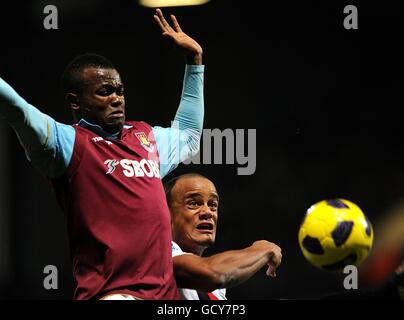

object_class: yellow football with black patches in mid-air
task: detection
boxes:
[298,199,373,271]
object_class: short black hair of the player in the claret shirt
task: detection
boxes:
[61,53,116,94]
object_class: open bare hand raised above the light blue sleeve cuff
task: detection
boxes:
[153,9,203,64]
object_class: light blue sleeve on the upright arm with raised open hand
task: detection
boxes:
[153,65,204,178]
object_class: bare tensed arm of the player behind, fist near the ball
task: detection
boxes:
[173,240,282,291]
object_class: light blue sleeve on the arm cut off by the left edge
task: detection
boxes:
[0,78,75,178]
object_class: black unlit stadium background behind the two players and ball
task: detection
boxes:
[0,0,404,299]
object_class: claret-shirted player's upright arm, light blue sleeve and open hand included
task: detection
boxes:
[153,9,204,177]
